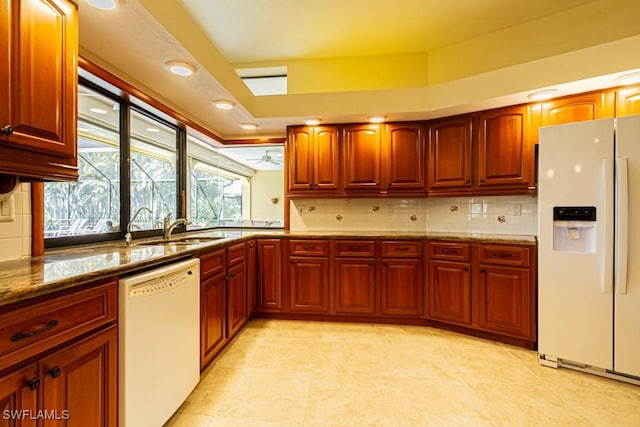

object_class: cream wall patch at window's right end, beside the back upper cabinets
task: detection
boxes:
[251,171,285,223]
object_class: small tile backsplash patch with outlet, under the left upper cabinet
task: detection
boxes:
[0,183,31,261]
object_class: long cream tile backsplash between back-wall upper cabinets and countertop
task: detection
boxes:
[290,196,536,235]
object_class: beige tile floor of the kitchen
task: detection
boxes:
[166,319,640,427]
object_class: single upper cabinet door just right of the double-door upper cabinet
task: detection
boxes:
[342,125,382,190]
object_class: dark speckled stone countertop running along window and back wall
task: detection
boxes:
[0,229,536,306]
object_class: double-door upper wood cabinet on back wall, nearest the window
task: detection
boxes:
[286,126,340,193]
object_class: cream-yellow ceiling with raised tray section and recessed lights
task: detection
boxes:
[79,0,640,140]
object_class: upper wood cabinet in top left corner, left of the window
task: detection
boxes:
[0,0,78,180]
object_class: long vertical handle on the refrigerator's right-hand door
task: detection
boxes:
[616,157,629,295]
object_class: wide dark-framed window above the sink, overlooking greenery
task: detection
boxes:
[44,69,283,248]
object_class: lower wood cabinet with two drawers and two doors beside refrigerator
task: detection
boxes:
[427,241,536,344]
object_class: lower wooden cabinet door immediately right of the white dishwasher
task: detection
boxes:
[200,272,227,369]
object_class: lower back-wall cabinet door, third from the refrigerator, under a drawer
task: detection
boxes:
[380,259,423,316]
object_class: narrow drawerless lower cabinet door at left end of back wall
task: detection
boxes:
[256,239,282,311]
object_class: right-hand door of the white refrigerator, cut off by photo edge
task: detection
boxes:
[613,116,640,377]
